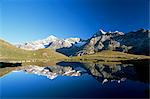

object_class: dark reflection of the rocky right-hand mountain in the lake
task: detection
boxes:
[57,60,149,83]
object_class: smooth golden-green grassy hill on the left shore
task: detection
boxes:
[0,40,67,61]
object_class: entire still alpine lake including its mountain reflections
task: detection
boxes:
[0,60,150,99]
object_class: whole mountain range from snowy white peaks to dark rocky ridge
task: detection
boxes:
[12,29,150,56]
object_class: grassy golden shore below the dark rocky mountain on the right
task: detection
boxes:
[67,50,150,62]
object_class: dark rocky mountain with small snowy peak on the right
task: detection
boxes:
[76,29,150,56]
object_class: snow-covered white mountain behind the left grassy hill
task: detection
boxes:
[16,35,84,50]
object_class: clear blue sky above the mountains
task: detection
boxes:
[0,0,149,43]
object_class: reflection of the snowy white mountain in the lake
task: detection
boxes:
[17,65,80,79]
